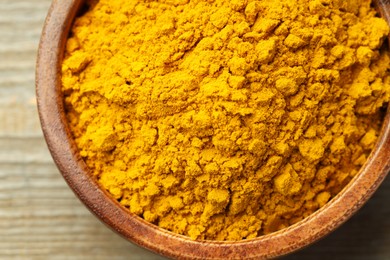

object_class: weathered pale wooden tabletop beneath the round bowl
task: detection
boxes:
[0,0,390,260]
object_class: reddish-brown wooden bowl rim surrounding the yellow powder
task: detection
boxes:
[36,0,390,259]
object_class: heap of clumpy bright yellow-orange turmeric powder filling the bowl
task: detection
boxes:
[62,0,390,240]
